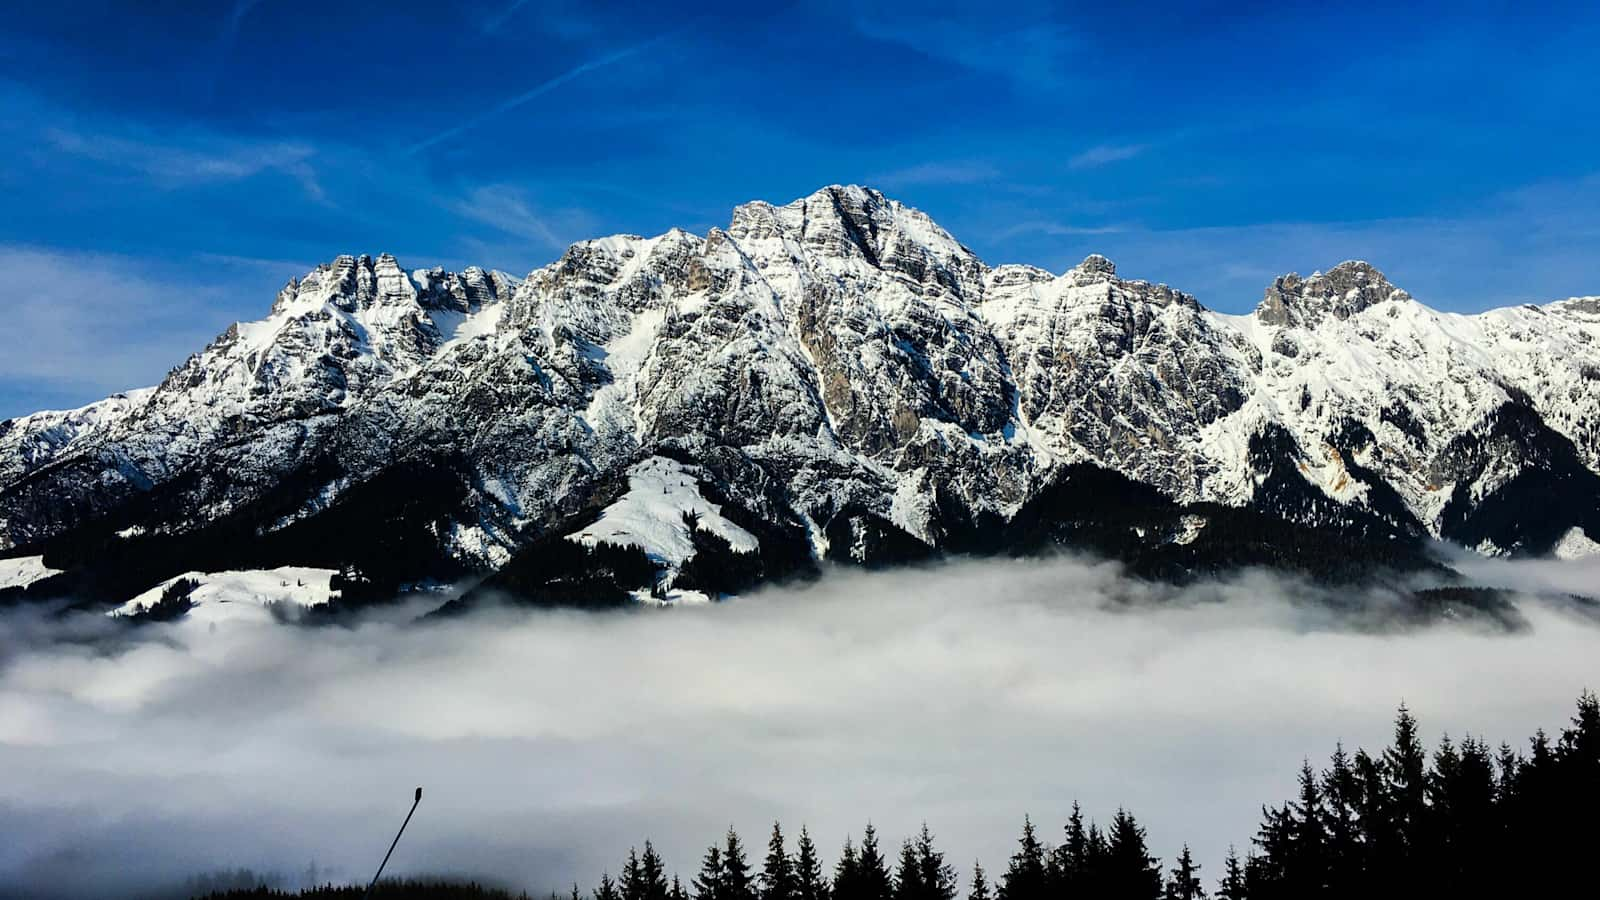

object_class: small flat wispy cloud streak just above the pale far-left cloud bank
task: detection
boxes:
[45,128,325,200]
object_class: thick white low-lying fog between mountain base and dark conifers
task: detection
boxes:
[0,559,1600,897]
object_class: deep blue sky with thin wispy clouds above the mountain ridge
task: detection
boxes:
[0,0,1600,416]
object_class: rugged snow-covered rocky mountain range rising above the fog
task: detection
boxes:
[0,186,1600,602]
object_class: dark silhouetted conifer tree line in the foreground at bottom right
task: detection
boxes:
[193,692,1600,900]
